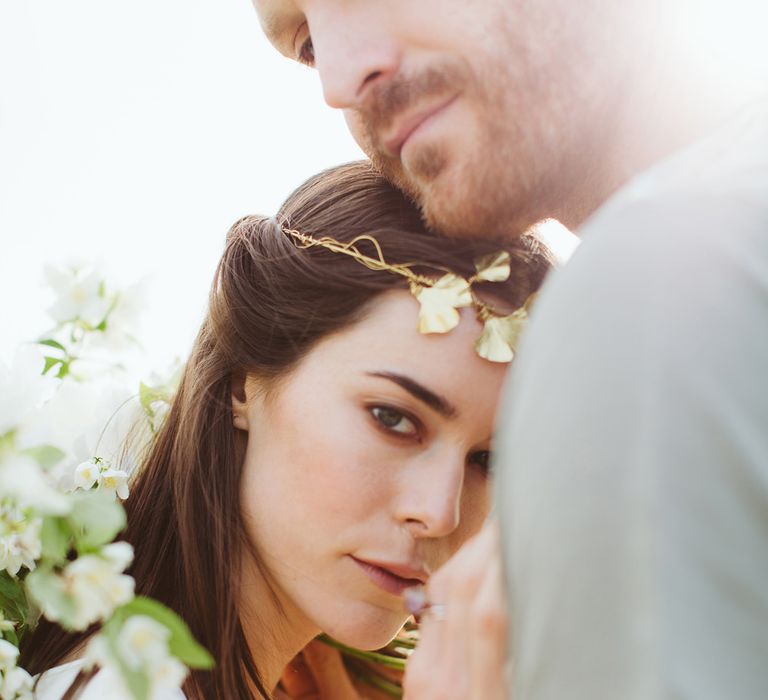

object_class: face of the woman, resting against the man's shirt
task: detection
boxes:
[235,290,506,648]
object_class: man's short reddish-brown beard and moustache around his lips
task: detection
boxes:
[356,56,542,238]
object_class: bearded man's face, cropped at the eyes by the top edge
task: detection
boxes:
[254,0,632,236]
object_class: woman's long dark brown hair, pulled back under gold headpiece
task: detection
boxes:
[21,162,551,700]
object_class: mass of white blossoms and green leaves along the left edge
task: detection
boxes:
[0,266,207,700]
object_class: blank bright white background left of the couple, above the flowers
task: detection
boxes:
[0,0,362,368]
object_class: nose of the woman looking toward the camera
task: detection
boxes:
[397,451,466,537]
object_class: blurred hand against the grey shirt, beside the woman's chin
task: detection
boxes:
[404,524,507,700]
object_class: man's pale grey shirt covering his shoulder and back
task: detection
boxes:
[497,100,768,700]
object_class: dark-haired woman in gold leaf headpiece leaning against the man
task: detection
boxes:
[21,163,550,700]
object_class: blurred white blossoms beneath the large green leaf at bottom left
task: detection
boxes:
[85,615,187,700]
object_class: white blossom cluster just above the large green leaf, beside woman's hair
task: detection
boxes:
[38,542,135,630]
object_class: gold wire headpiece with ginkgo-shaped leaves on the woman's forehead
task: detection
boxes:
[283,229,535,362]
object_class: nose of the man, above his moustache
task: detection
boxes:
[309,2,400,109]
